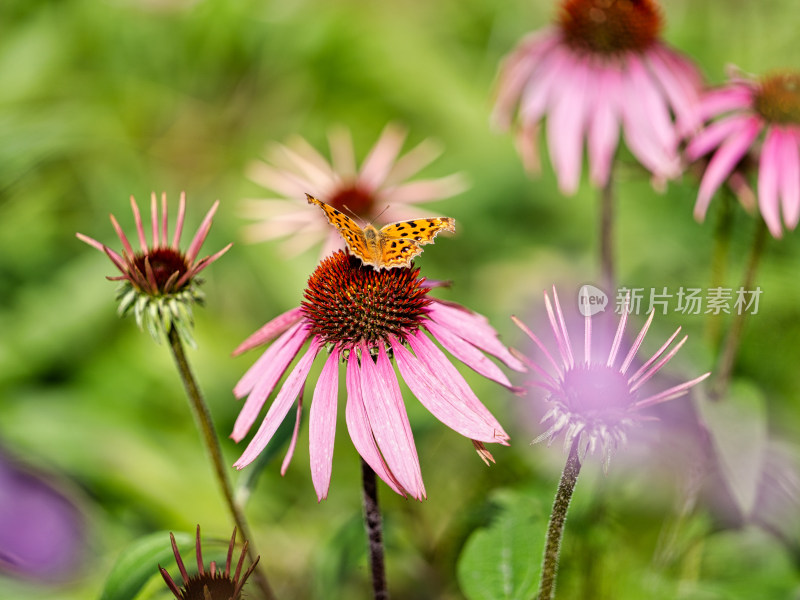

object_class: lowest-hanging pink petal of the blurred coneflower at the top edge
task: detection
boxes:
[546,58,590,195]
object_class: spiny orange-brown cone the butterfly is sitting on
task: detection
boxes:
[302,250,431,348]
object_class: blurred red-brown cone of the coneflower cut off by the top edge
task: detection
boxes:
[558,0,662,55]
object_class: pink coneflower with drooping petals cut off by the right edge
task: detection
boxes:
[686,73,800,238]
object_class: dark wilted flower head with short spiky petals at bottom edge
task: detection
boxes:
[158,525,260,600]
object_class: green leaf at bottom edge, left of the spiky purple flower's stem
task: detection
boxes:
[458,492,549,600]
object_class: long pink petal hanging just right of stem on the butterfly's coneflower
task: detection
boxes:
[361,344,425,500]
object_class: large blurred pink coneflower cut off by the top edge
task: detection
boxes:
[494,0,700,194]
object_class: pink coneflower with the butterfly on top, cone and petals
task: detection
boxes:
[231,251,524,500]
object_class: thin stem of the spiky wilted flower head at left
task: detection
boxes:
[168,327,275,600]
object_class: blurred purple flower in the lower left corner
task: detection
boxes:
[0,451,86,582]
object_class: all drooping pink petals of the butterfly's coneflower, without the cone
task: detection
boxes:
[231,300,524,500]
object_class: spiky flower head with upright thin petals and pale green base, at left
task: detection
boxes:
[76,193,231,345]
